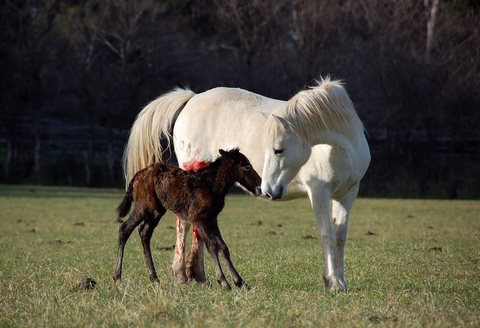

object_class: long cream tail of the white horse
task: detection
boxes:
[122,88,195,187]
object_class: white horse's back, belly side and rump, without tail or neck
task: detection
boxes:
[173,87,283,172]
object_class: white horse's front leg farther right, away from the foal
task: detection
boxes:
[332,184,358,290]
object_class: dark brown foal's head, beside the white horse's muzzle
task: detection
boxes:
[219,148,262,196]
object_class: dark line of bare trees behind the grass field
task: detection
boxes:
[0,0,480,197]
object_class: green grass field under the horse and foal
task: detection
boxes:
[0,185,480,327]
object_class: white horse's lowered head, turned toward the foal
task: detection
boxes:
[262,114,312,200]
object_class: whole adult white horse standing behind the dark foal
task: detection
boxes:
[124,77,370,291]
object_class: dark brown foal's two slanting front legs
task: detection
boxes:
[197,218,250,290]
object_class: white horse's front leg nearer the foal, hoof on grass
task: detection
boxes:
[309,187,348,291]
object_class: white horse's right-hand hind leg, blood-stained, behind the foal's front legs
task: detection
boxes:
[186,226,210,285]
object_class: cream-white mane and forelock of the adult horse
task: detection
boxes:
[266,76,363,142]
